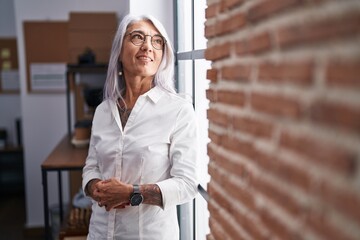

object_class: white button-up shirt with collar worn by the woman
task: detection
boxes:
[83,87,198,240]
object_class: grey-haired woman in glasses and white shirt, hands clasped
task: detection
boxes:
[83,16,197,240]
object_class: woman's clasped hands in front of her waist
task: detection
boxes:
[88,178,133,211]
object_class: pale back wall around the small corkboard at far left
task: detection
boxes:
[0,0,21,145]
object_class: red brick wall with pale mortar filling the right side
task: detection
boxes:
[205,0,360,240]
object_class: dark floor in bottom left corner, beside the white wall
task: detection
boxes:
[0,194,43,240]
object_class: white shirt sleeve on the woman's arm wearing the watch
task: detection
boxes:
[157,104,198,209]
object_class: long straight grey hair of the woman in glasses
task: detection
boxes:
[104,15,176,106]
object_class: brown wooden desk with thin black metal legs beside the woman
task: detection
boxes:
[41,135,88,239]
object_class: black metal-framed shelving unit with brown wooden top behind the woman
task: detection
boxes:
[41,64,107,239]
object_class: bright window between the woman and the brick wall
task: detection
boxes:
[174,0,210,240]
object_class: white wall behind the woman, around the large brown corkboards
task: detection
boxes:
[14,0,173,230]
